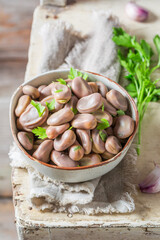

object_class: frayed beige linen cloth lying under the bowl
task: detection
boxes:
[9,12,137,215]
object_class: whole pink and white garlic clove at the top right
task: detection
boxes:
[125,1,149,22]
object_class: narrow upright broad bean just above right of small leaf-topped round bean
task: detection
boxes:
[76,129,92,154]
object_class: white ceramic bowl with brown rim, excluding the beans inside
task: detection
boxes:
[10,70,138,183]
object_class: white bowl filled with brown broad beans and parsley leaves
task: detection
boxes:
[10,68,138,182]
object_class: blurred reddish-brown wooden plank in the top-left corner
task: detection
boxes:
[0,0,39,59]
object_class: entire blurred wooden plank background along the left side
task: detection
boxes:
[0,0,39,240]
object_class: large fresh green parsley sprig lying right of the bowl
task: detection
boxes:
[112,28,160,154]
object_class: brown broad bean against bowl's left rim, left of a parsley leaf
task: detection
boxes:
[17,132,33,150]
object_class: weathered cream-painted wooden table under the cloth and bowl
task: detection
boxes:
[12,0,160,240]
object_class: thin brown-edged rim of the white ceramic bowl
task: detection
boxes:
[10,69,139,171]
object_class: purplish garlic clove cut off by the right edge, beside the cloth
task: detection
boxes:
[139,165,160,193]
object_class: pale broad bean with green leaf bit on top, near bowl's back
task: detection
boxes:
[51,82,71,103]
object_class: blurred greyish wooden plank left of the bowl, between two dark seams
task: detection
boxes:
[0,61,26,197]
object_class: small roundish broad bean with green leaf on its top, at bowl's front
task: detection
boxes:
[69,141,84,161]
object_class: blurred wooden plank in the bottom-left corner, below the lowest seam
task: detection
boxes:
[0,199,17,240]
